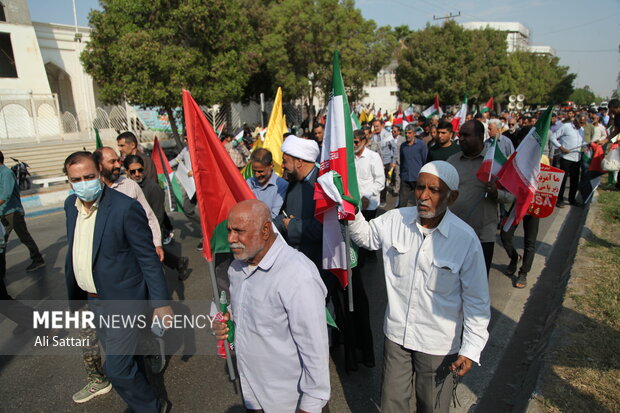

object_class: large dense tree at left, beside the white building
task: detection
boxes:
[81,0,250,147]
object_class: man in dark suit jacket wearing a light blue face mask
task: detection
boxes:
[64,152,173,412]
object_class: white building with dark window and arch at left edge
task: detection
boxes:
[0,0,96,144]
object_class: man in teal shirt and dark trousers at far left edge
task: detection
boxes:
[0,152,45,271]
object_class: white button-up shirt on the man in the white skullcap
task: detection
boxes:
[350,207,491,363]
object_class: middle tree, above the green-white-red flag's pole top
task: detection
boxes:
[262,0,396,119]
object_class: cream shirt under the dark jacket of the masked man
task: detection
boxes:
[73,195,101,294]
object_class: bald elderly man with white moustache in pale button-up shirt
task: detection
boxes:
[213,200,330,413]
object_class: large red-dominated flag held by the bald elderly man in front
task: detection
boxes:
[183,90,255,261]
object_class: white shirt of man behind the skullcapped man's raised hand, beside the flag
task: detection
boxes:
[355,148,385,211]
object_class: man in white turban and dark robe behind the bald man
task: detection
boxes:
[274,135,323,268]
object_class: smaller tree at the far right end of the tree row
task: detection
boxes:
[508,51,576,105]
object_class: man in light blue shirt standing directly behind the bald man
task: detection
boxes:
[246,148,288,218]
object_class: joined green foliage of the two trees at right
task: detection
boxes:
[396,21,576,105]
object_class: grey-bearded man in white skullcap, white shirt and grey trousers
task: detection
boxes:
[350,161,491,413]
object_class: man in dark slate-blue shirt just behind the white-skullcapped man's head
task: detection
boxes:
[398,125,428,208]
